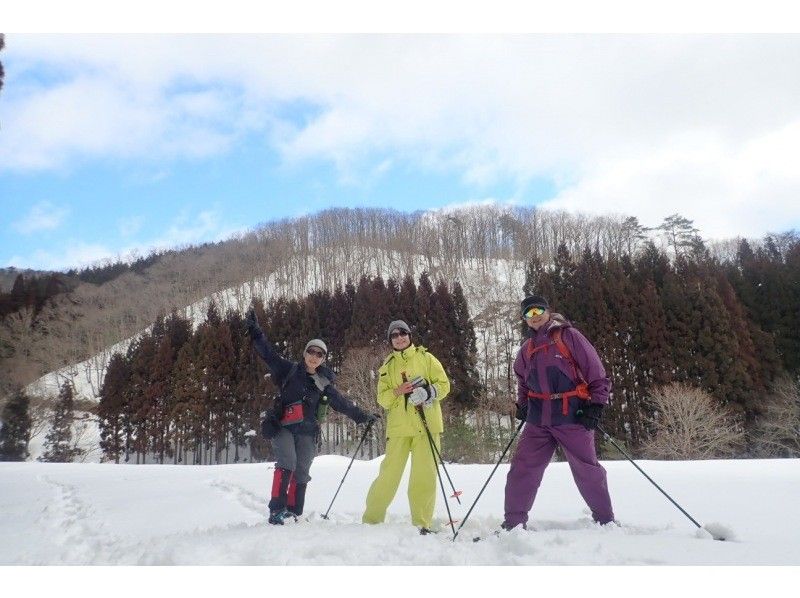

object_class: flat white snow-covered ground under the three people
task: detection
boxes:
[0,456,800,565]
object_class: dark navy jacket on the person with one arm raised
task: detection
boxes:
[253,330,369,435]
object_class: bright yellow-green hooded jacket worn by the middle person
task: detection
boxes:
[378,344,450,438]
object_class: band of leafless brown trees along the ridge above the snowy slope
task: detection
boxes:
[0,207,656,392]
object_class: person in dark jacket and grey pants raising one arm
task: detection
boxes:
[245,308,377,525]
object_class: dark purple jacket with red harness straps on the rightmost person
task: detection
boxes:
[514,313,611,426]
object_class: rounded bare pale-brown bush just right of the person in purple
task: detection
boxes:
[642,383,744,460]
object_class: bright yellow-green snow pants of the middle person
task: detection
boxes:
[361,432,441,529]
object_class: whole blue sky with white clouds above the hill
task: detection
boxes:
[0,34,800,269]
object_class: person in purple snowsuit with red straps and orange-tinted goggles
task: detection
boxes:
[502,296,614,530]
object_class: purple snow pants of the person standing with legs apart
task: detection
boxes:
[505,424,614,528]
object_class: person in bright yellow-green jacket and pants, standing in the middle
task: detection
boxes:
[361,320,450,534]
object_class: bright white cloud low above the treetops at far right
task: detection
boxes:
[544,120,800,238]
